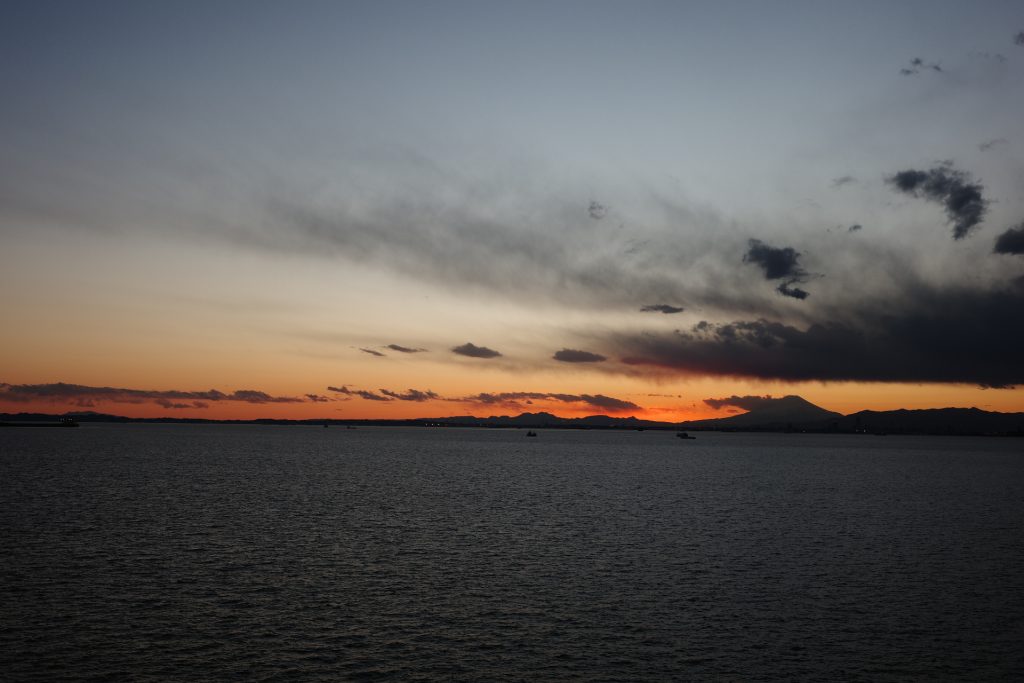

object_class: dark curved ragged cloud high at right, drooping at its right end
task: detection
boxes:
[886,163,988,240]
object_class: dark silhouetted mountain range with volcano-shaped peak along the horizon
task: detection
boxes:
[0,396,1024,436]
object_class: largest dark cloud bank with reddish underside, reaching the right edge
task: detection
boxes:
[617,287,1024,387]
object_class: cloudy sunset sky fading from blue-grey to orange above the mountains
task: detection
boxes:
[0,0,1024,421]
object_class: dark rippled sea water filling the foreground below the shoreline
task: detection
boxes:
[0,425,1024,681]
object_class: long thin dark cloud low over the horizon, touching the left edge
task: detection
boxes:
[0,382,309,409]
